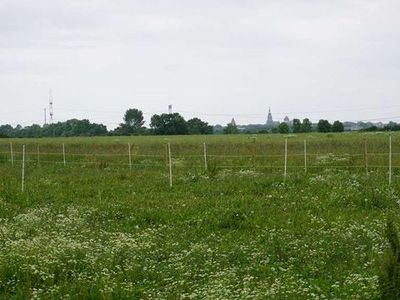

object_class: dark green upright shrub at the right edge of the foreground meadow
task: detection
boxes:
[379,220,400,300]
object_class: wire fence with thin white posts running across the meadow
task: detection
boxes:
[0,136,400,190]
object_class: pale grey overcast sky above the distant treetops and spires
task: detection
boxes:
[0,0,400,128]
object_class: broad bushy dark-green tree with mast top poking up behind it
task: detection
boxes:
[150,113,189,135]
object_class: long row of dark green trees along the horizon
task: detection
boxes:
[0,108,400,138]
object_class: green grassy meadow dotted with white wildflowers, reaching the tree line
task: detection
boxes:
[0,133,400,299]
